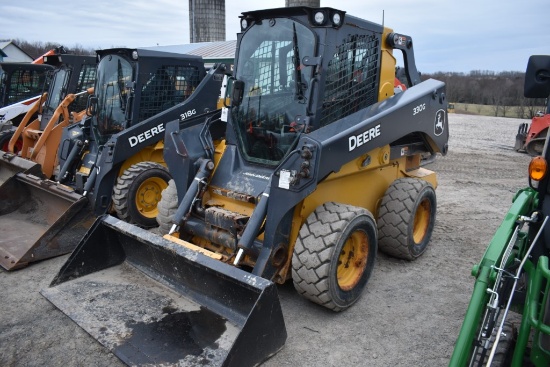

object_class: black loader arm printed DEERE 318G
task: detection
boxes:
[89,64,226,215]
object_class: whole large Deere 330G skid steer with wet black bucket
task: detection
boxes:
[41,7,449,366]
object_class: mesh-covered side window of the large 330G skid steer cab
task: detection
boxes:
[321,34,380,126]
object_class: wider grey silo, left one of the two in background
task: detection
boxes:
[189,0,225,43]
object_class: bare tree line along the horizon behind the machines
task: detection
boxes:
[14,39,546,119]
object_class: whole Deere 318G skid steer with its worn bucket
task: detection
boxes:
[0,48,229,270]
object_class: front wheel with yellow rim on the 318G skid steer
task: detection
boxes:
[113,162,172,228]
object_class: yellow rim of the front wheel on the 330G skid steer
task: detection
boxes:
[337,231,369,291]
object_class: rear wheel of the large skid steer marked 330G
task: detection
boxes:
[378,178,437,260]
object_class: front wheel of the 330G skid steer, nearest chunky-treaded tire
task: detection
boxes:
[292,202,377,312]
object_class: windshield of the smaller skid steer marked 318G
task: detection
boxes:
[95,55,133,140]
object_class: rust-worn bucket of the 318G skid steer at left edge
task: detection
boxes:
[0,173,95,270]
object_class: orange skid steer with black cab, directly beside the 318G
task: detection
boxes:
[0,54,96,184]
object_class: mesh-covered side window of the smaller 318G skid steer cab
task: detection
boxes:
[139,65,200,121]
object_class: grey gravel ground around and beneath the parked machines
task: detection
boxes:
[0,114,529,367]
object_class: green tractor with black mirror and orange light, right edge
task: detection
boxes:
[449,56,550,367]
